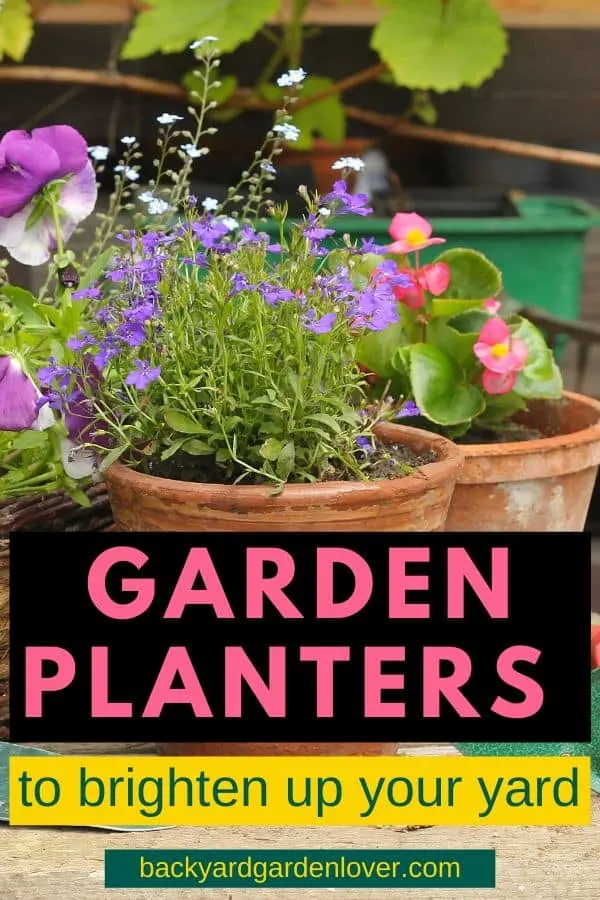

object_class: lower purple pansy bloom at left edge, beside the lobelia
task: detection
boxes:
[0,356,55,431]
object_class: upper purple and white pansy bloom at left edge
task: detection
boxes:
[0,125,98,266]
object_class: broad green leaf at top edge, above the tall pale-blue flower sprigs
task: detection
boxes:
[121,0,279,59]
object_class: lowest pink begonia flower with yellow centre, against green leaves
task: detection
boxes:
[473,317,527,394]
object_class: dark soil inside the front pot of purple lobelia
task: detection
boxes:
[141,444,438,484]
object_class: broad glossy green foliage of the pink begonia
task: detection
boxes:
[357,249,562,438]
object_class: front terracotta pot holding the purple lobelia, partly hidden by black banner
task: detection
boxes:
[106,424,462,756]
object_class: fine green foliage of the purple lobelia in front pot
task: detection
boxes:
[61,230,364,484]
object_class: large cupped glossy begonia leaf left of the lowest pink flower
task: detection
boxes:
[410,344,485,425]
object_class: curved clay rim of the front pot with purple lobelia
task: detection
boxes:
[105,423,464,510]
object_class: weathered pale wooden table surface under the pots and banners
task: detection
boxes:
[0,744,600,900]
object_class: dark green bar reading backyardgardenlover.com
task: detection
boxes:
[104,850,496,888]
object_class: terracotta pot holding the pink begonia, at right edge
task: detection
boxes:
[446,392,600,531]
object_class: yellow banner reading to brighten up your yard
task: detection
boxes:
[10,756,591,826]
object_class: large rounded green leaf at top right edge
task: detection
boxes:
[371,0,508,93]
